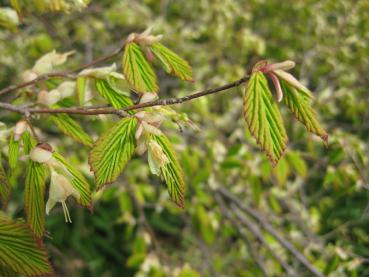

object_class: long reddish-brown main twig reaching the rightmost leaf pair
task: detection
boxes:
[0,75,249,116]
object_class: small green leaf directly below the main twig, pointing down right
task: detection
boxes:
[50,114,93,147]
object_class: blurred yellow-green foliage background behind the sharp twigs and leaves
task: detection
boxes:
[0,0,369,277]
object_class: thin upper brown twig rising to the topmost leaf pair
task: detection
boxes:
[0,43,125,96]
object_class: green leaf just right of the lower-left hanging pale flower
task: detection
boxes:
[53,152,92,210]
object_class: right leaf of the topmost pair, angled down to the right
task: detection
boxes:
[150,42,193,81]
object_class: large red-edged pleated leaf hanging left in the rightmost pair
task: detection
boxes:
[243,72,288,166]
